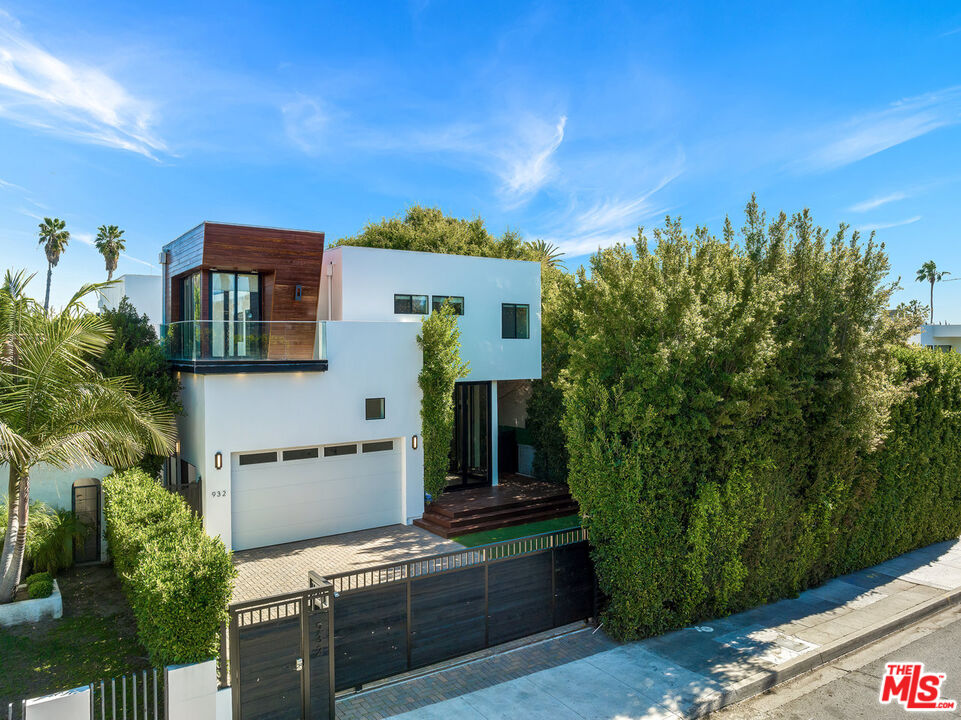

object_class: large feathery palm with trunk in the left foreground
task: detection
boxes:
[0,271,175,603]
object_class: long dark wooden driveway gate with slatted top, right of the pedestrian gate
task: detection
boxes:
[309,528,595,690]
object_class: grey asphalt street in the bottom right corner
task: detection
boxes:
[710,607,961,720]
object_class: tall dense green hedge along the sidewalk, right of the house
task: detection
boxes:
[557,200,961,638]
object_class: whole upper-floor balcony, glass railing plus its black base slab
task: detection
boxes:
[161,320,327,373]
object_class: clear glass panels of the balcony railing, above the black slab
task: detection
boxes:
[160,320,327,362]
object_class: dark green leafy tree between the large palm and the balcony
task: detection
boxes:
[94,297,183,477]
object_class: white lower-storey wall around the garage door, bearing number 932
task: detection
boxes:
[180,322,424,547]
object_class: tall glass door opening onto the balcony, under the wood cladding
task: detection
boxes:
[210,272,267,358]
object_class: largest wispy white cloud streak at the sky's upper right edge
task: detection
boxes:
[798,86,961,171]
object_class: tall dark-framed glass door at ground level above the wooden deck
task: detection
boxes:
[447,382,491,490]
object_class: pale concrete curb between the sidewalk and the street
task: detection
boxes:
[684,588,961,718]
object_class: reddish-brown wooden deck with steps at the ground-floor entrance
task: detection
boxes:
[414,479,578,538]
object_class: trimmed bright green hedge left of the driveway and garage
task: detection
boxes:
[103,469,236,666]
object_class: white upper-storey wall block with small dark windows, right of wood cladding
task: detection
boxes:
[318,247,541,381]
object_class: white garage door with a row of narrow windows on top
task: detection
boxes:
[230,439,404,550]
